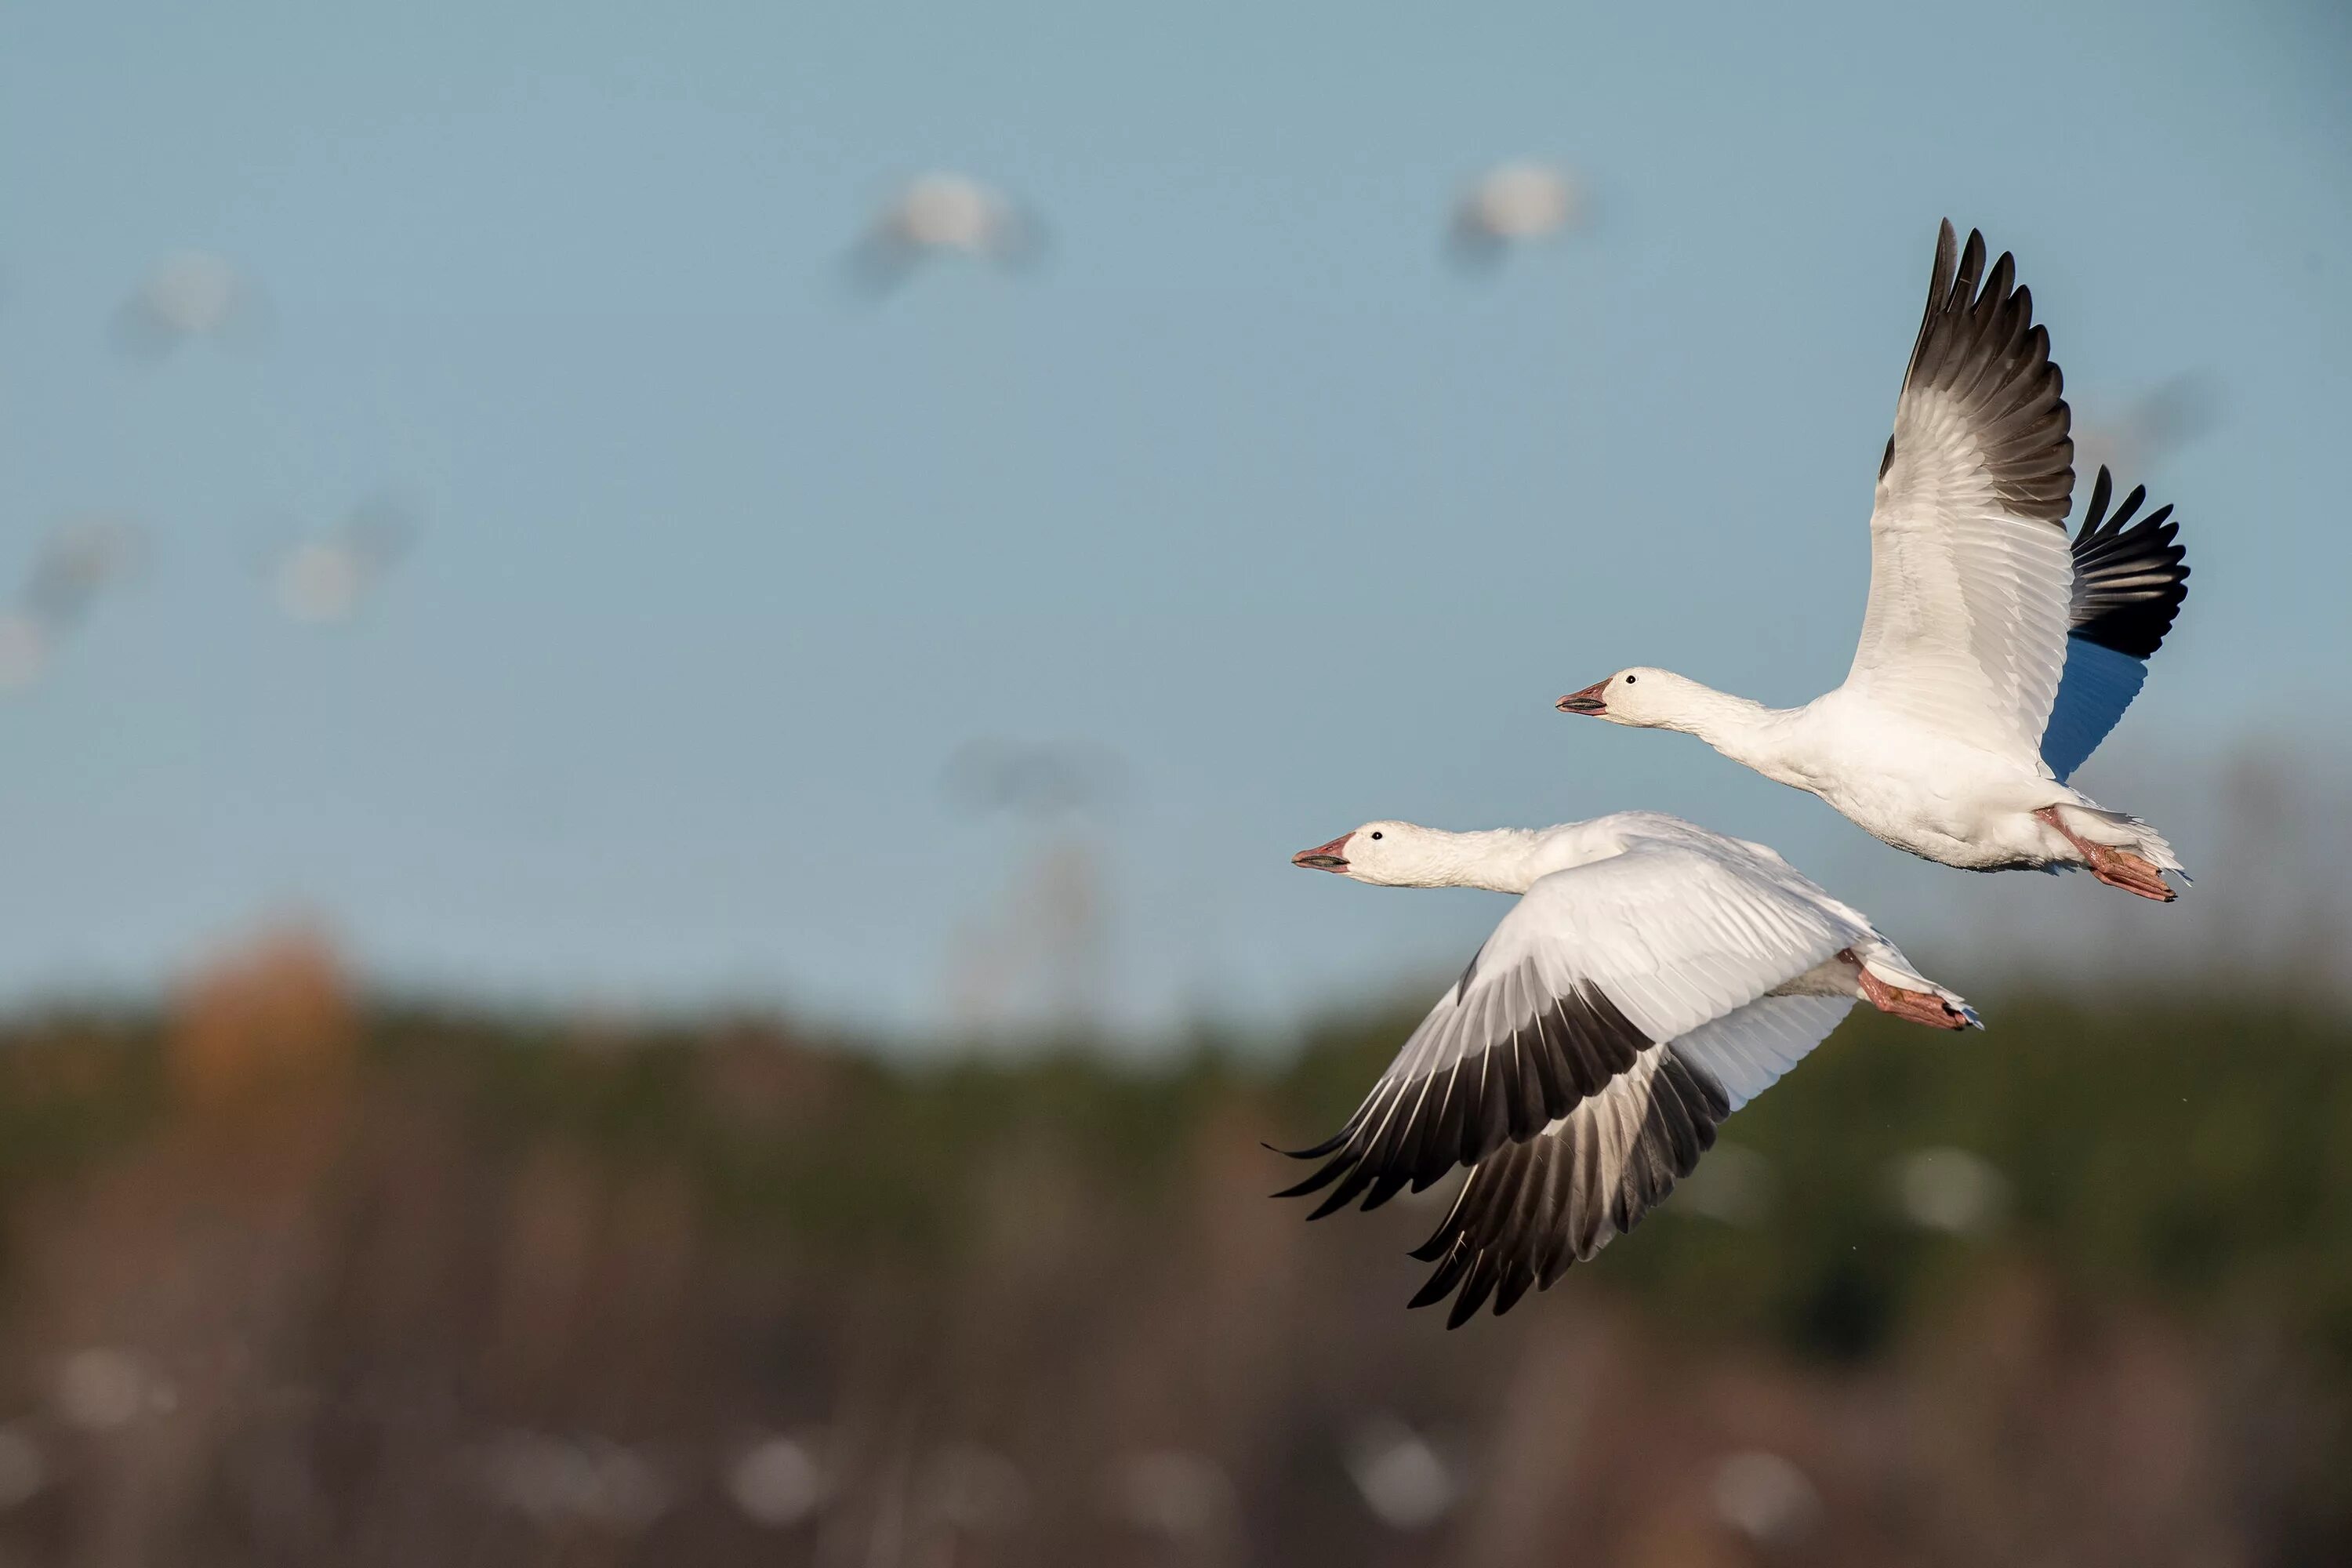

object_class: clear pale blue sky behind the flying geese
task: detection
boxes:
[0,0,2352,1044]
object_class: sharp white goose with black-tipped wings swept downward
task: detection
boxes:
[1277,811,1976,1328]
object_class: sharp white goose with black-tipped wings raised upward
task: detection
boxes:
[1559,223,2190,902]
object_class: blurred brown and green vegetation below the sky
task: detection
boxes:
[0,931,2352,1563]
